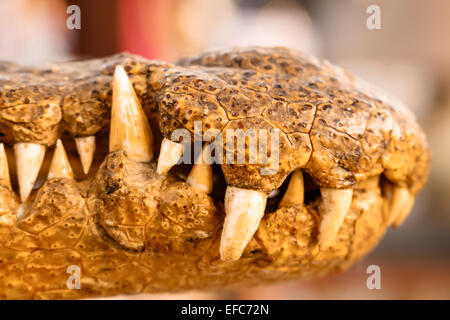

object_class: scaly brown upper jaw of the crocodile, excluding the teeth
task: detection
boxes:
[0,48,429,194]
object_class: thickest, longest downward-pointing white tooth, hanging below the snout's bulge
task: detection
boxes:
[219,186,267,261]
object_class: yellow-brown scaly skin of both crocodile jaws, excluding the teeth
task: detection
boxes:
[0,48,430,299]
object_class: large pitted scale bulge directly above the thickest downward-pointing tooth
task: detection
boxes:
[221,117,312,192]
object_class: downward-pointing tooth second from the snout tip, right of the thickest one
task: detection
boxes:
[319,188,353,249]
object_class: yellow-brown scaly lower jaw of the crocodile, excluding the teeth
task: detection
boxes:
[0,146,389,298]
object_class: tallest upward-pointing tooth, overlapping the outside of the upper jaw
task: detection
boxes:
[109,66,153,162]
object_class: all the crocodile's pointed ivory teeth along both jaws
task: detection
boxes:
[0,66,414,261]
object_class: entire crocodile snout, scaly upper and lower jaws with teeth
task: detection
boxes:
[0,48,429,298]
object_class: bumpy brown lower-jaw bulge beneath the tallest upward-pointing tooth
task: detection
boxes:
[89,151,162,250]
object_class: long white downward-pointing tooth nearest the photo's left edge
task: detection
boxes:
[14,142,45,202]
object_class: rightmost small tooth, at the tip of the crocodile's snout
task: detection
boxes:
[388,187,415,227]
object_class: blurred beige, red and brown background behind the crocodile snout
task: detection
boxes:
[0,0,450,299]
